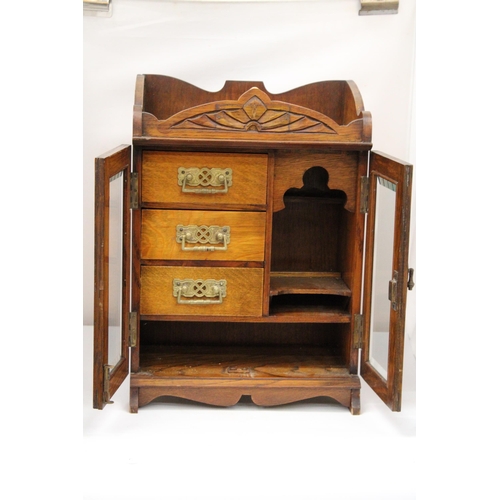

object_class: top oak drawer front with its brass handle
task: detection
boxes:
[142,151,267,209]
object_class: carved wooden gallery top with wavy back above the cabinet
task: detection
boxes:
[133,75,371,150]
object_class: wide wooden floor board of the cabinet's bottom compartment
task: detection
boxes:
[141,345,349,379]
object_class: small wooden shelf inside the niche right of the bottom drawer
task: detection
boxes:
[269,272,351,297]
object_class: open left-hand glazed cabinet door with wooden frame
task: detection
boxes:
[93,146,131,410]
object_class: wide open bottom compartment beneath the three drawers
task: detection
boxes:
[140,321,349,378]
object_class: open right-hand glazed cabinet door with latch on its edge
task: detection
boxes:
[361,152,412,411]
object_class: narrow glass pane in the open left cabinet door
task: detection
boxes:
[108,172,123,366]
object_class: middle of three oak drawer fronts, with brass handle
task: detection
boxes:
[141,210,266,262]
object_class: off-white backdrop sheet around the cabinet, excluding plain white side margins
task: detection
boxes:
[83,0,418,500]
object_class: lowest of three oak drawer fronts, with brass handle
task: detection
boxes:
[141,266,263,316]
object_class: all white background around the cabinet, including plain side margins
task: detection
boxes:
[2,0,500,500]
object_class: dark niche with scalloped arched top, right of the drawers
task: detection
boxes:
[270,167,352,314]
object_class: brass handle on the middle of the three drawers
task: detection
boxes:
[175,224,231,252]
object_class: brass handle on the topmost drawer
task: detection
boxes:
[177,167,233,194]
